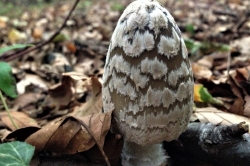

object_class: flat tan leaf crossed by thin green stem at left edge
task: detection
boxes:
[0,111,39,130]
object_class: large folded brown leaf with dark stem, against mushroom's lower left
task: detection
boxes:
[25,113,111,154]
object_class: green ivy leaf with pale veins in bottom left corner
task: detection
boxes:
[0,141,35,166]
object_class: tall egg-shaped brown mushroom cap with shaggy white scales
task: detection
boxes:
[102,0,194,145]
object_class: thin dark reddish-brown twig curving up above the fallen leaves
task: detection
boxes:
[0,0,80,62]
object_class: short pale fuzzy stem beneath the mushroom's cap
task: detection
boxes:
[122,141,167,166]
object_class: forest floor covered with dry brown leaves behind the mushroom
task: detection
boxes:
[0,0,250,165]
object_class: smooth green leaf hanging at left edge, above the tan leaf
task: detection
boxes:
[0,62,17,98]
